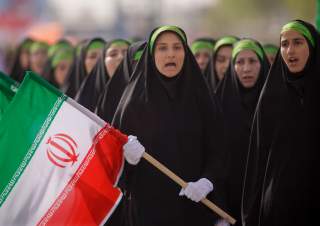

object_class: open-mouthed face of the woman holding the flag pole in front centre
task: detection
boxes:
[154,32,185,78]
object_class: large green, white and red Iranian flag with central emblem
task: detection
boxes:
[0,72,127,225]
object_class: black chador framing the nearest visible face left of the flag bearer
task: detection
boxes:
[75,39,130,113]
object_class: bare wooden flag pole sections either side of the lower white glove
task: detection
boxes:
[142,152,236,224]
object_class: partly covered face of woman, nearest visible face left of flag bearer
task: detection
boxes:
[104,44,128,77]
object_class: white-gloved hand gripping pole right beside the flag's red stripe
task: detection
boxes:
[123,135,145,165]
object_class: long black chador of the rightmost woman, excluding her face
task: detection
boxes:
[242,20,320,226]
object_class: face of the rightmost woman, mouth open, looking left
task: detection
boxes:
[280,30,309,73]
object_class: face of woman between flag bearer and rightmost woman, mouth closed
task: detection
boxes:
[234,50,261,88]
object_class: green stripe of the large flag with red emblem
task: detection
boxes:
[0,72,67,206]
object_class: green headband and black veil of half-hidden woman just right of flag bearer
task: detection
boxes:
[204,36,239,93]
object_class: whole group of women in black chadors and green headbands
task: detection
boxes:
[11,20,320,226]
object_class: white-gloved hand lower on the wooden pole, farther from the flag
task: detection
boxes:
[179,178,213,202]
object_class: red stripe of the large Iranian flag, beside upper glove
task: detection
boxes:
[38,124,127,225]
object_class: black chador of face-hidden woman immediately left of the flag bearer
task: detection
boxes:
[95,41,146,122]
